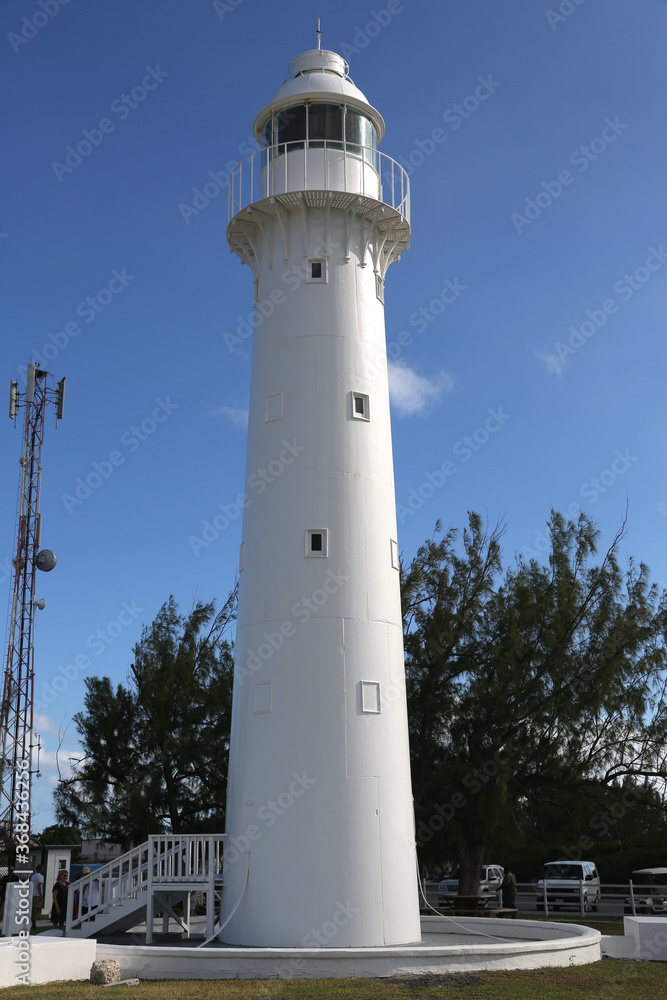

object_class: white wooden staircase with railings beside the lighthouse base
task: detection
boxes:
[67,833,226,944]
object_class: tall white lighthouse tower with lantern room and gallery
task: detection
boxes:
[221,41,420,948]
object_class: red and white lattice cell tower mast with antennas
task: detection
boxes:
[0,364,65,844]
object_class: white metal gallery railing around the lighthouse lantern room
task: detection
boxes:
[229,139,410,222]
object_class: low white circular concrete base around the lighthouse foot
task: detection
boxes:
[96,916,601,979]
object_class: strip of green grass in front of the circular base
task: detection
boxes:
[1,959,667,1000]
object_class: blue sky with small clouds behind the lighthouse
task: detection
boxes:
[0,0,667,830]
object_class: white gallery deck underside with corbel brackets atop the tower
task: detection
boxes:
[227,190,410,280]
